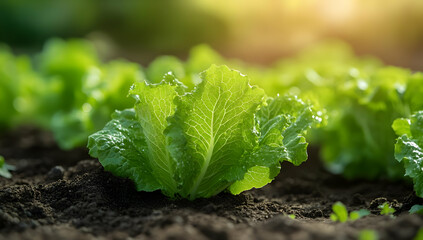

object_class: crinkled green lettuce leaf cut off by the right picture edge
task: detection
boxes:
[392,111,423,197]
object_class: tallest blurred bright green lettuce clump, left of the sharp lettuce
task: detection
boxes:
[36,39,100,113]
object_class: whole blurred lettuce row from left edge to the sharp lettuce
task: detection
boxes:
[0,39,142,149]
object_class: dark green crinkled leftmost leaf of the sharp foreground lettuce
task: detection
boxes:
[88,109,161,191]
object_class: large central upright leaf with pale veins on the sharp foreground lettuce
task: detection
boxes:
[170,66,264,199]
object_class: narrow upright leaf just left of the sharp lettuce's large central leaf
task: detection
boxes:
[130,76,179,196]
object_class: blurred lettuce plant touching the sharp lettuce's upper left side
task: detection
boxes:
[50,60,142,149]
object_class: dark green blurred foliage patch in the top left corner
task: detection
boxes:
[0,0,98,46]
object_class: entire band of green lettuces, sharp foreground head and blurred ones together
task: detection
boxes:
[0,40,423,198]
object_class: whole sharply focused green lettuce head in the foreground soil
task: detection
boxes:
[88,65,319,200]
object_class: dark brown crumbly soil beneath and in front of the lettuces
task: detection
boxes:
[0,126,423,240]
